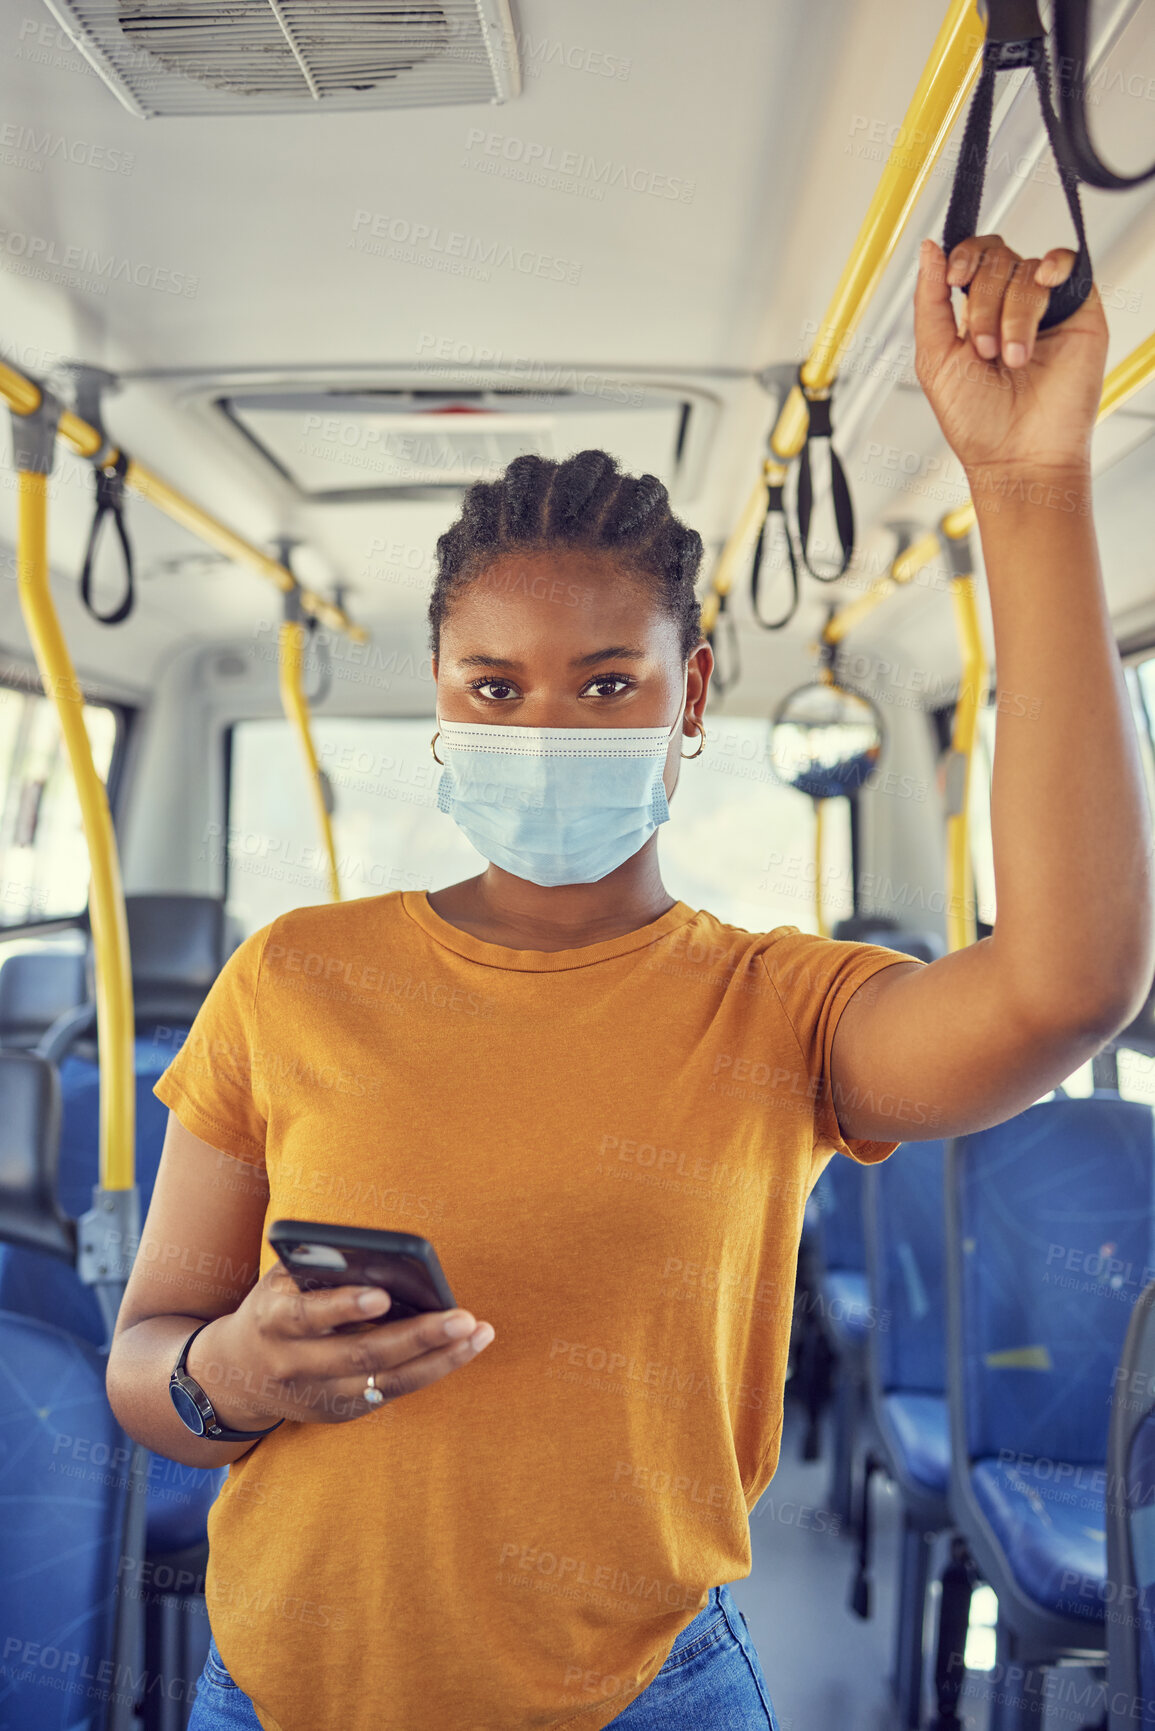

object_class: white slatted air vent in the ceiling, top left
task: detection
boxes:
[45,0,521,119]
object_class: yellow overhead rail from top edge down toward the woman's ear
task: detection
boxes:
[701,0,984,639]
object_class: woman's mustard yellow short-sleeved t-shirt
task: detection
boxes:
[156,891,923,1731]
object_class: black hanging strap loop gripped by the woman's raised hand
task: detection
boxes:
[942,0,1094,331]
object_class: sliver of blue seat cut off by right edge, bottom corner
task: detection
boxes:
[1107,1269,1155,1731]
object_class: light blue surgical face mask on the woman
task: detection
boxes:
[436,663,689,886]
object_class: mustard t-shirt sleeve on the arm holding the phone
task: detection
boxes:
[152,923,274,1167]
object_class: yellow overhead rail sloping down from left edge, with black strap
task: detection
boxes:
[0,362,369,642]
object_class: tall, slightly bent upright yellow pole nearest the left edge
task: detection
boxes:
[16,474,137,1189]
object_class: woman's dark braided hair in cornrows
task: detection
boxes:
[429,450,703,661]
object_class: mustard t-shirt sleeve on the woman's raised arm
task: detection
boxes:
[762,926,926,1165]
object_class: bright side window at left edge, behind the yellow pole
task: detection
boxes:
[0,685,118,954]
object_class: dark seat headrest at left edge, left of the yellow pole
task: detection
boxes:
[0,1052,76,1265]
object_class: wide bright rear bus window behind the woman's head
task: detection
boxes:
[225,715,854,931]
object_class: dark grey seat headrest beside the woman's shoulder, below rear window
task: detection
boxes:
[88,895,227,1032]
